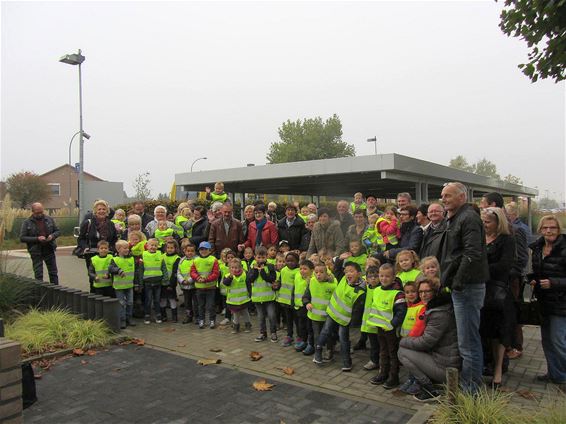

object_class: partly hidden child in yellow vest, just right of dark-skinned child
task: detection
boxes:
[293,259,314,355]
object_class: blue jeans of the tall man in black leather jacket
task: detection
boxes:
[452,283,485,393]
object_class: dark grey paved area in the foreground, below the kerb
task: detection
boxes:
[24,345,411,424]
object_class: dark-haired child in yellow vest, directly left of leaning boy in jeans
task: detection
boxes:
[303,262,338,361]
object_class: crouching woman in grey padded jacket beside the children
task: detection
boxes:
[398,278,461,402]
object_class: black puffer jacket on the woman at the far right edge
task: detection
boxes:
[529,234,566,316]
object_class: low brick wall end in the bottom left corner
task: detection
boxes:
[0,337,23,424]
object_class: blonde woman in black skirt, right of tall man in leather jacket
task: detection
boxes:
[480,208,517,389]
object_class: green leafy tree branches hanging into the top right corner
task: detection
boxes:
[499,0,566,82]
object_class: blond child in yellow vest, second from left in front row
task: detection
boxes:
[108,240,139,329]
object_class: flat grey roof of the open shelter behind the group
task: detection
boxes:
[175,153,538,200]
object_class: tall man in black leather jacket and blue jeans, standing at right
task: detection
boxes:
[440,182,489,393]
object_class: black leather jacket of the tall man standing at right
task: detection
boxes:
[440,204,489,291]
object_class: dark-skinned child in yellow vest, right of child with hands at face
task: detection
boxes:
[276,252,301,347]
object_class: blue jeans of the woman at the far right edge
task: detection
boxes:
[540,315,566,384]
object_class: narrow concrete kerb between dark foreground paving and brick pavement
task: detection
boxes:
[144,342,422,418]
